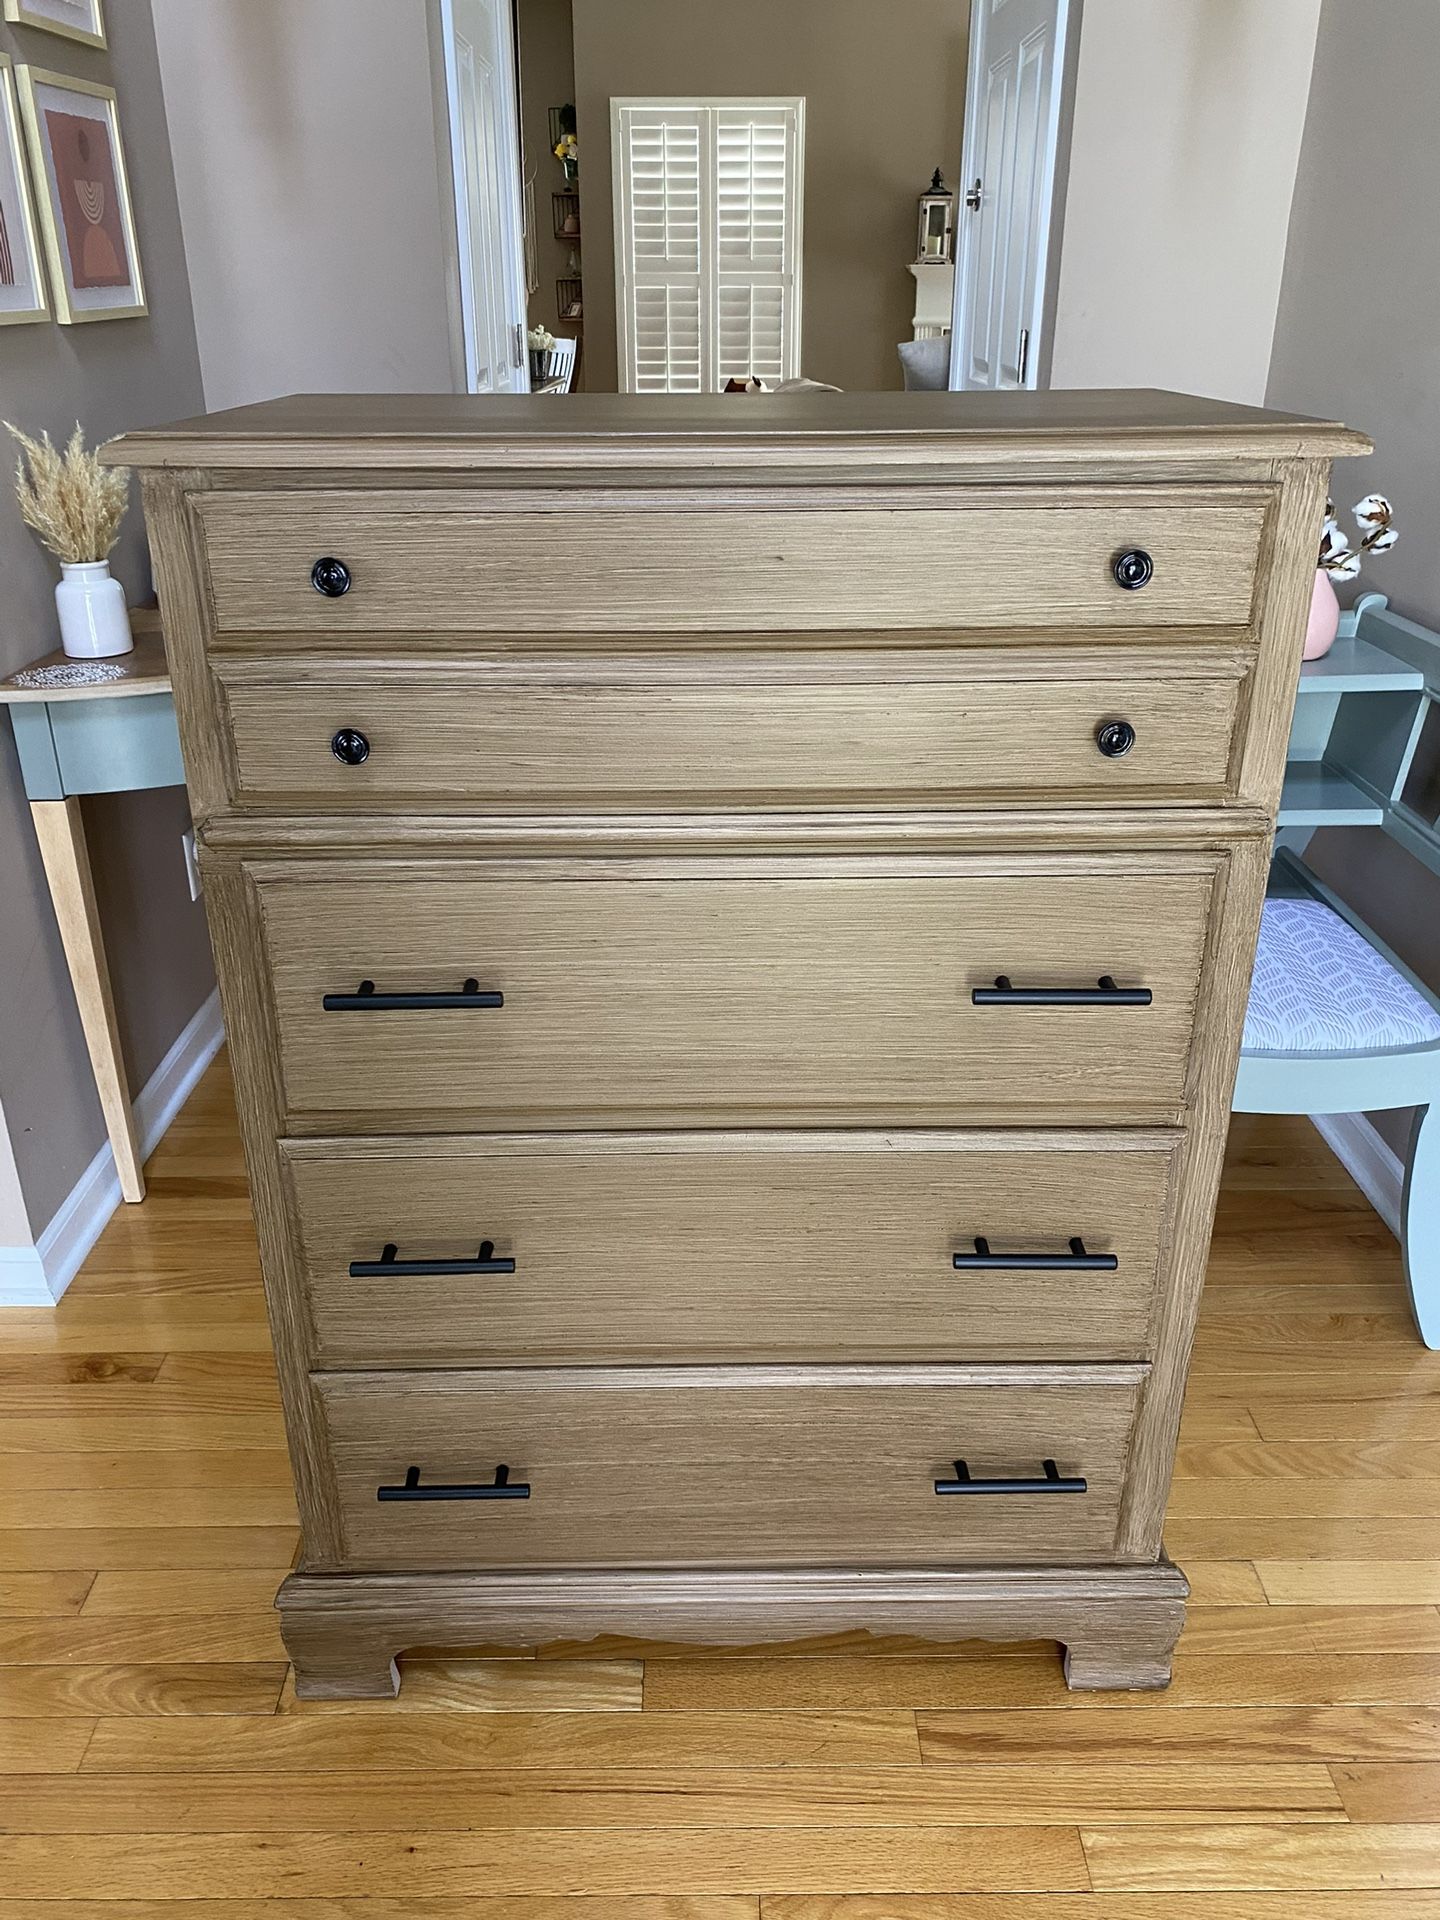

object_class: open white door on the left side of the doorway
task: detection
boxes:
[442,0,530,394]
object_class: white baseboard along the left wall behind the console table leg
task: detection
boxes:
[0,993,223,1308]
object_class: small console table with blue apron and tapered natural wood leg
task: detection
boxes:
[0,611,184,1200]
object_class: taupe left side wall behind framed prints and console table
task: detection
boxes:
[0,0,213,1244]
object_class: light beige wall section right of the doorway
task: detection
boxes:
[1052,0,1328,403]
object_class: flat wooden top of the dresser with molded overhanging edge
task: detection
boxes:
[108,388,1371,468]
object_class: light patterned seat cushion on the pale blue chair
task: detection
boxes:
[1244,899,1440,1054]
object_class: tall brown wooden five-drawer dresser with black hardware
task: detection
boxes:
[113,394,1367,1695]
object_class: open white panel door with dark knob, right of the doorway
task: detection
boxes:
[950,0,1069,388]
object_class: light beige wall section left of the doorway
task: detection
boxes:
[154,0,455,409]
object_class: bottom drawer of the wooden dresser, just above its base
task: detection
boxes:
[313,1367,1144,1572]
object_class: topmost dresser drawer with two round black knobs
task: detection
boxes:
[196,488,1267,637]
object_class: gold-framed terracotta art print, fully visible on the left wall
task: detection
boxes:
[15,67,146,326]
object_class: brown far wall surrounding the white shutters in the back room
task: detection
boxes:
[568,0,970,392]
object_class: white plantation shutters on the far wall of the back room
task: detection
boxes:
[611,100,804,394]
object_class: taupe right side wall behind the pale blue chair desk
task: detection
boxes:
[1267,0,1440,1144]
